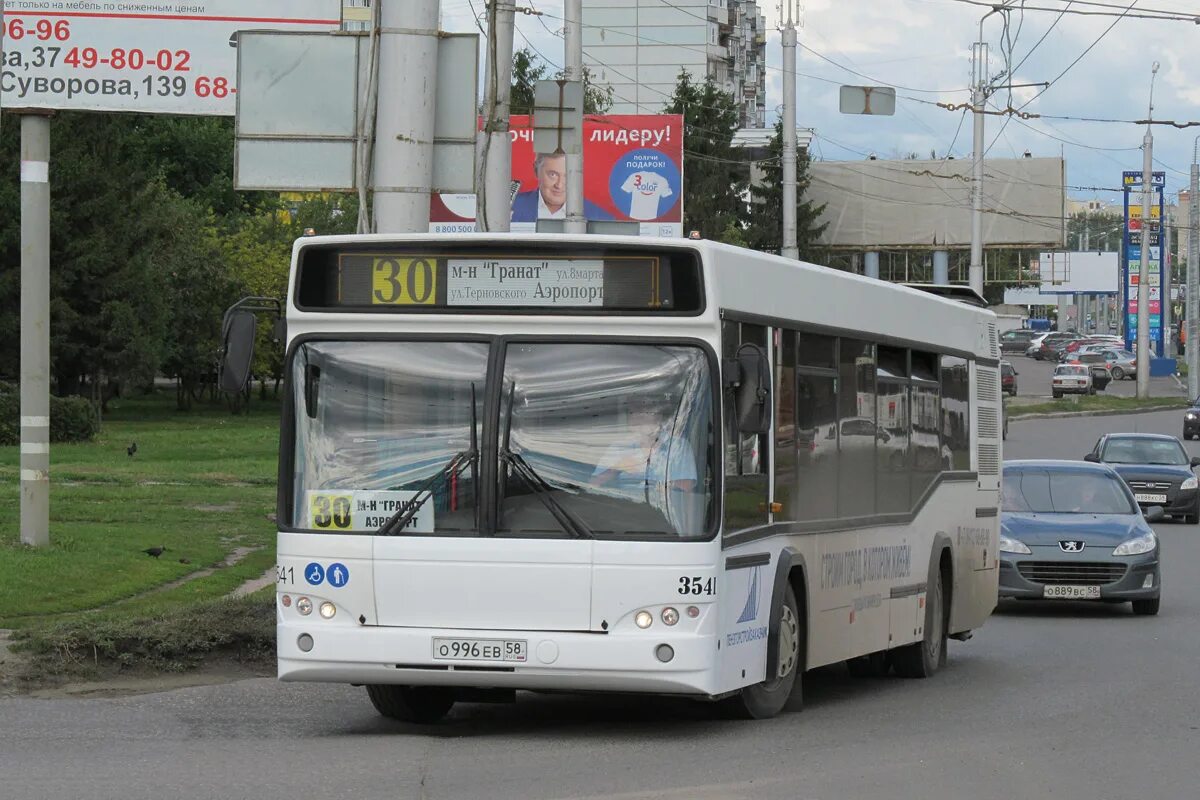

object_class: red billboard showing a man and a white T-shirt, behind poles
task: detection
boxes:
[430,114,683,236]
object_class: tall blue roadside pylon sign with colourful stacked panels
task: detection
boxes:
[1121,172,1166,356]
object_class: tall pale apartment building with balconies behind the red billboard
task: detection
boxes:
[583,0,767,128]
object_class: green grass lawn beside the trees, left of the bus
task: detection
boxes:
[0,392,278,675]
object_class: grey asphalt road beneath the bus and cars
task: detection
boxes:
[0,413,1200,800]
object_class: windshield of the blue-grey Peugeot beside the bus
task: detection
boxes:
[1001,469,1138,515]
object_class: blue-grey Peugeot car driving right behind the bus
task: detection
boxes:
[1000,461,1163,615]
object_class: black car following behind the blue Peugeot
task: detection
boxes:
[1084,433,1200,524]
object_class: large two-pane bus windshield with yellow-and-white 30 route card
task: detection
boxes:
[289,341,715,539]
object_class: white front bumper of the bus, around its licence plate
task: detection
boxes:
[276,619,718,696]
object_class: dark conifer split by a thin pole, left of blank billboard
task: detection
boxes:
[746,122,828,260]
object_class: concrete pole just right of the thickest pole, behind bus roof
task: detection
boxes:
[475,0,516,231]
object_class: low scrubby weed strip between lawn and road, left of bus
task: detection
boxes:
[12,587,275,684]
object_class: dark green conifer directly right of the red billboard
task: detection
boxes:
[662,70,748,239]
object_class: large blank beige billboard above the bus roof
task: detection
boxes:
[805,158,1067,249]
